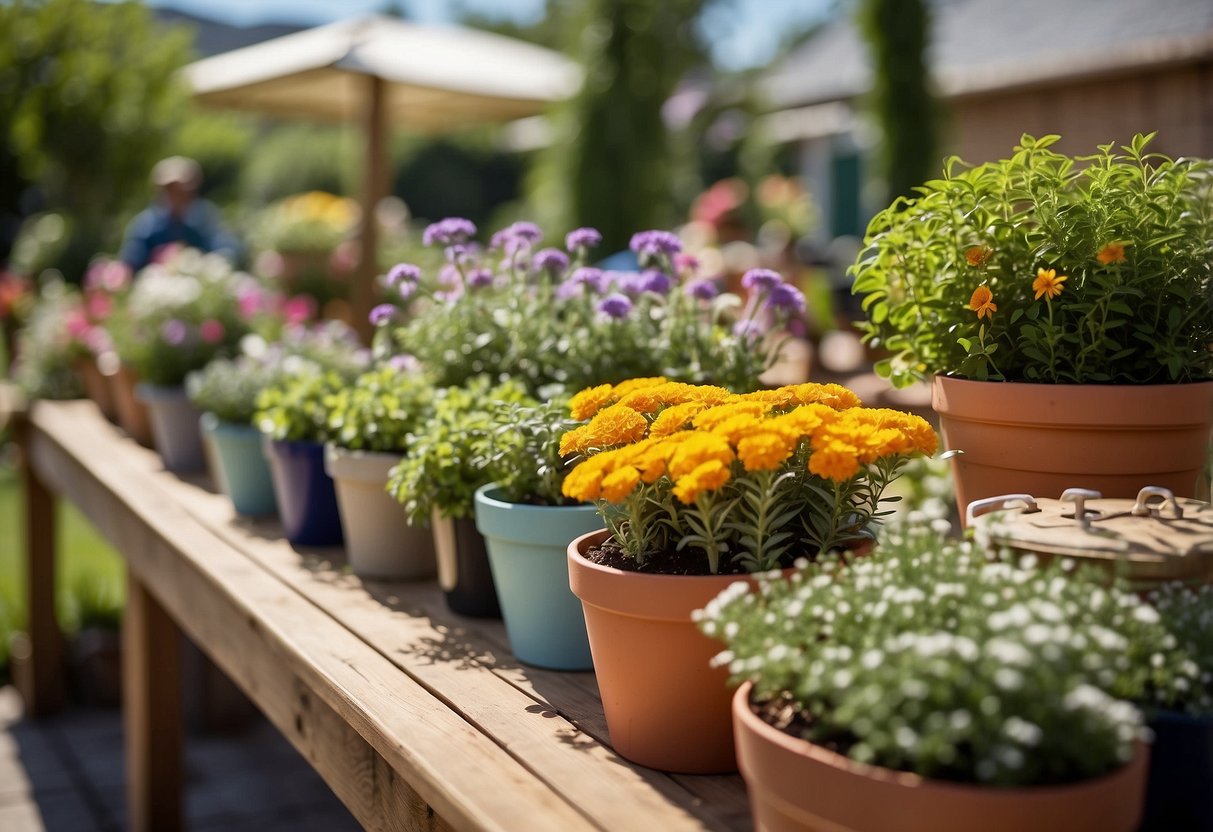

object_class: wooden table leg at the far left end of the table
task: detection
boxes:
[13,415,64,717]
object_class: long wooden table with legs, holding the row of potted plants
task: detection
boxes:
[17,401,751,832]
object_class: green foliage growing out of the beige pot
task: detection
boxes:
[328,365,433,454]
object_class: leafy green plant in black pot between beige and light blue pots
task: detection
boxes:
[388,377,525,617]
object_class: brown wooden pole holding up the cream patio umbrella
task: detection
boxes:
[351,75,389,344]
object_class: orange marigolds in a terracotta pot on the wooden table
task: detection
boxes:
[560,378,936,773]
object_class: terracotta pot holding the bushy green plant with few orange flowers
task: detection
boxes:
[932,376,1213,517]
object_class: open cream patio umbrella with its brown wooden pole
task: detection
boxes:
[184,16,581,334]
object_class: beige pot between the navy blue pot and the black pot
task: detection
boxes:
[324,443,434,580]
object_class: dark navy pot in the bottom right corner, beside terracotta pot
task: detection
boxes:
[1140,711,1213,832]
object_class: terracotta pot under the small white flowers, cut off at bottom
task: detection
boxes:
[733,683,1150,832]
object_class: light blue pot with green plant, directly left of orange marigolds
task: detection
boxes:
[475,399,602,671]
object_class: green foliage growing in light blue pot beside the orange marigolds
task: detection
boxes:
[484,398,580,506]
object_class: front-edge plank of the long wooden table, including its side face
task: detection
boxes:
[32,403,593,831]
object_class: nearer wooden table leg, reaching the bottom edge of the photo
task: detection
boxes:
[123,569,182,832]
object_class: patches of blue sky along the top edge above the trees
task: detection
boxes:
[135,0,833,70]
